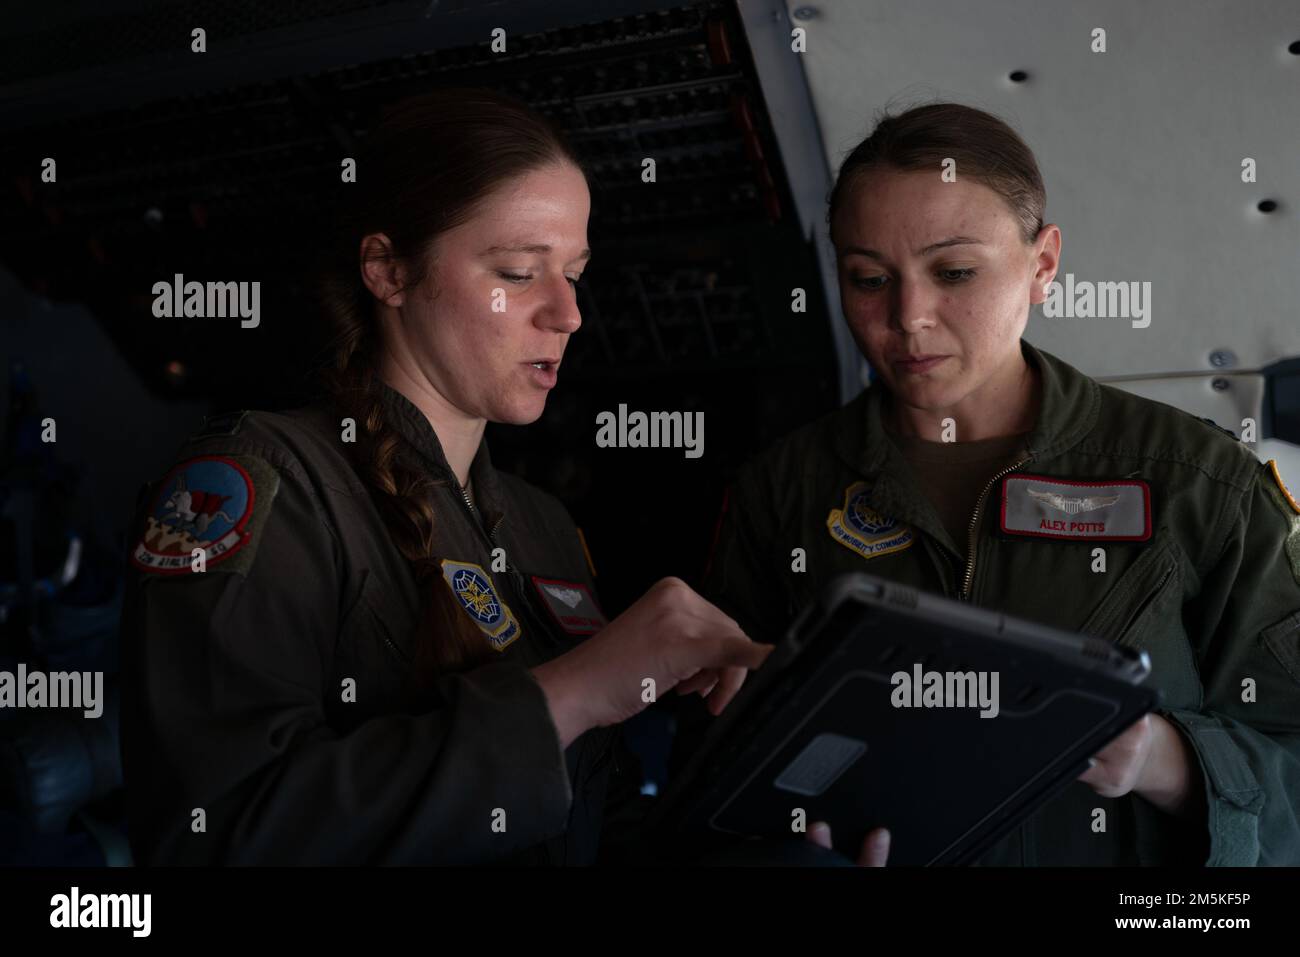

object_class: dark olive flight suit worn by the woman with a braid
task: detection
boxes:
[122,386,642,863]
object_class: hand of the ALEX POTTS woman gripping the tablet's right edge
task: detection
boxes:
[1079,714,1195,815]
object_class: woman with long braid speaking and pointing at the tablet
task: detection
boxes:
[124,90,767,863]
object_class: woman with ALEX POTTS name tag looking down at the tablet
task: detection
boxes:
[705,103,1300,865]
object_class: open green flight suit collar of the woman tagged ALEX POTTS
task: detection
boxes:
[833,339,1101,541]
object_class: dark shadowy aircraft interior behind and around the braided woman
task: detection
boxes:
[0,0,839,863]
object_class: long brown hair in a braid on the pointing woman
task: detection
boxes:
[317,90,581,680]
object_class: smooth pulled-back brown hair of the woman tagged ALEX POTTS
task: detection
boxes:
[827,103,1048,243]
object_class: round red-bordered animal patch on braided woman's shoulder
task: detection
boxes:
[131,455,280,575]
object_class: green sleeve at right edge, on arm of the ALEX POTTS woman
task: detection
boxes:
[1164,465,1300,866]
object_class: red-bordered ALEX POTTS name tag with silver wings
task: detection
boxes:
[1000,473,1151,542]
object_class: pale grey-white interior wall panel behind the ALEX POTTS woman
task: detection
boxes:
[741,0,1300,484]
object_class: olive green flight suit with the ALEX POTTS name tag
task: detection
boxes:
[705,341,1300,865]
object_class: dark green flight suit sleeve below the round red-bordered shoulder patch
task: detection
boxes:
[122,445,572,865]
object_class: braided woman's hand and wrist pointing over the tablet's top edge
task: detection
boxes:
[533,579,772,748]
